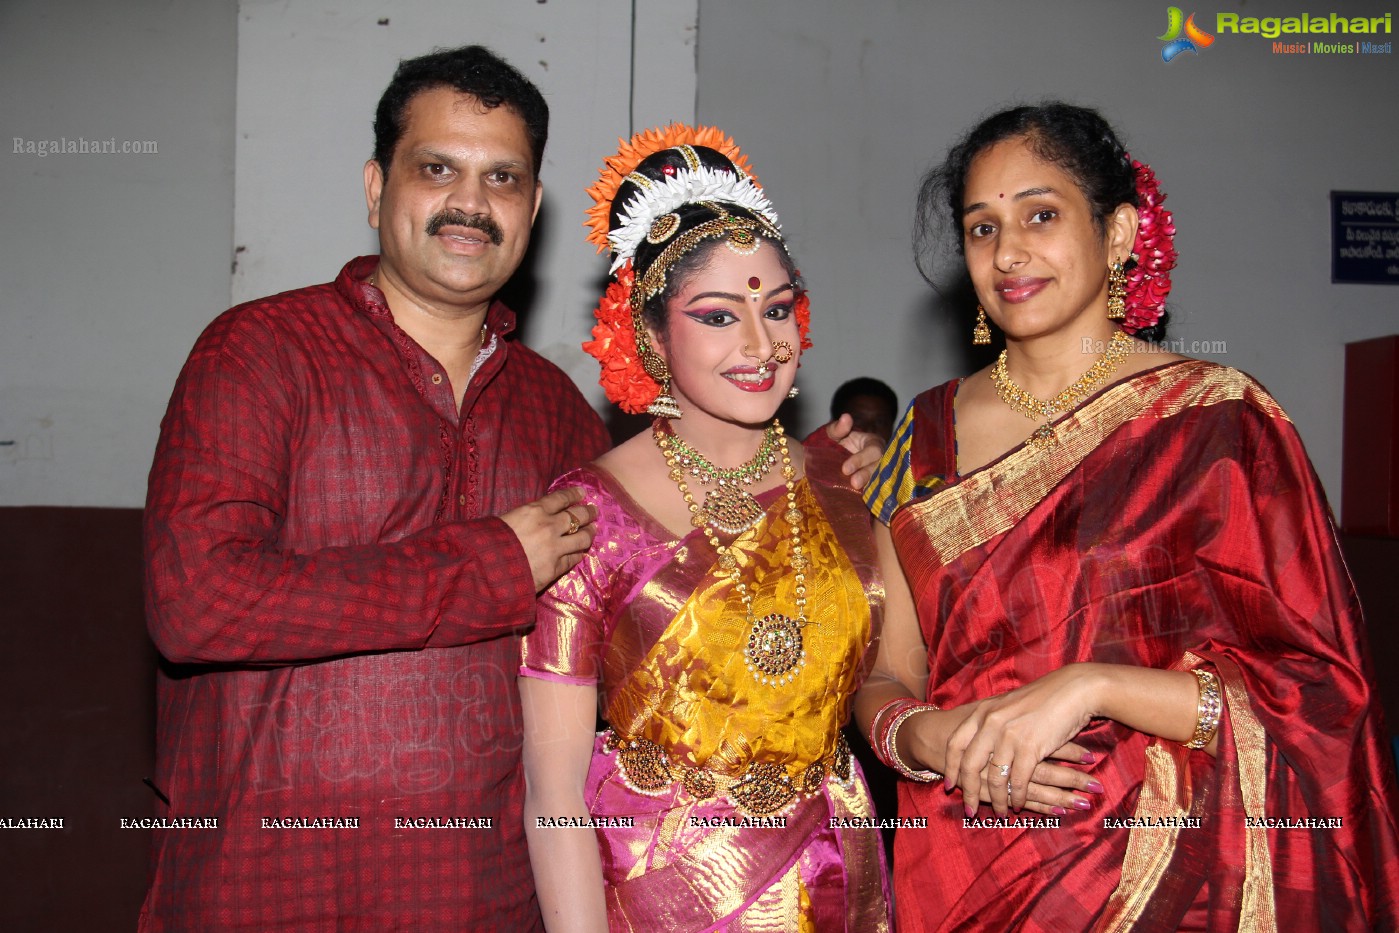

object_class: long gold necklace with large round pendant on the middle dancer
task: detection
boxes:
[652,418,809,685]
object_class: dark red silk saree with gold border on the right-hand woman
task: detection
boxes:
[867,361,1399,933]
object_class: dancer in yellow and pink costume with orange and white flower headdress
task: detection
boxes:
[520,126,888,932]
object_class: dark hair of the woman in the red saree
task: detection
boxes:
[914,101,1167,340]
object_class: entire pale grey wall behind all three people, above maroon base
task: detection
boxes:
[0,0,1399,506]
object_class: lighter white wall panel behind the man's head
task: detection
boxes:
[234,0,697,407]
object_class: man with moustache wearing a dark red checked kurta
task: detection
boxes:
[141,48,607,930]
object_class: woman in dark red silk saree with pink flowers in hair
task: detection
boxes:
[856,104,1399,933]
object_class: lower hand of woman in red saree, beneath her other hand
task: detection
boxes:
[898,704,1102,817]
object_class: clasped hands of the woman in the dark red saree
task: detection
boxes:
[946,664,1102,816]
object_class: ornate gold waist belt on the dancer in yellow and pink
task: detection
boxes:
[604,729,851,817]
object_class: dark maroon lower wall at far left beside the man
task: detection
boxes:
[0,508,155,930]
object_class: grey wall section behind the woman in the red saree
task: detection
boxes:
[698,0,1399,502]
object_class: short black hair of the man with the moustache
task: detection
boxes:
[374,45,548,175]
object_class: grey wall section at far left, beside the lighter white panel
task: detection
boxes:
[0,0,236,506]
